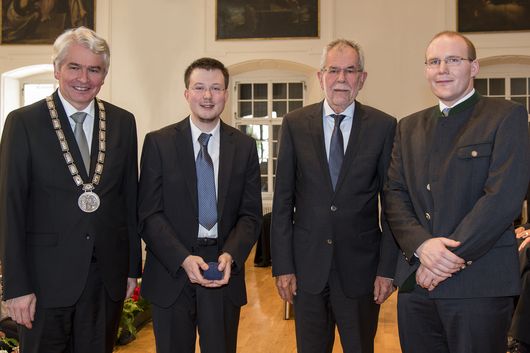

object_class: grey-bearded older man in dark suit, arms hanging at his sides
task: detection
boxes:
[271,39,397,353]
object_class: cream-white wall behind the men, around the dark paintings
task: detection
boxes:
[0,0,530,144]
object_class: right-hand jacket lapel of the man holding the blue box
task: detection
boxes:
[217,121,236,218]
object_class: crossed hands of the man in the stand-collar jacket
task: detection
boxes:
[416,237,466,291]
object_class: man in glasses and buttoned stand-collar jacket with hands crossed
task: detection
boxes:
[385,32,530,353]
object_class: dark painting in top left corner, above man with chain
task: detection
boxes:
[1,0,95,44]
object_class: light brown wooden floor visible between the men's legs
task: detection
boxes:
[115,250,401,353]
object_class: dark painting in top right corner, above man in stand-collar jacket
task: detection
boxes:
[458,0,530,32]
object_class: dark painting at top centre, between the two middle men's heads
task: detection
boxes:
[216,0,319,39]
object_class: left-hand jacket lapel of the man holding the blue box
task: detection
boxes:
[175,116,198,214]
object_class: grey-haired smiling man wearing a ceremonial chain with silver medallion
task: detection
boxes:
[0,27,141,353]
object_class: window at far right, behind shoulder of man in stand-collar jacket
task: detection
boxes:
[475,77,530,110]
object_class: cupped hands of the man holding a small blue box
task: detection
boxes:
[181,252,232,288]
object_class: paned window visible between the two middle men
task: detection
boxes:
[233,80,305,196]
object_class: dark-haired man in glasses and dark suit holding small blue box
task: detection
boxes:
[138,58,261,353]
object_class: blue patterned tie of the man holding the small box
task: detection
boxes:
[195,133,217,230]
